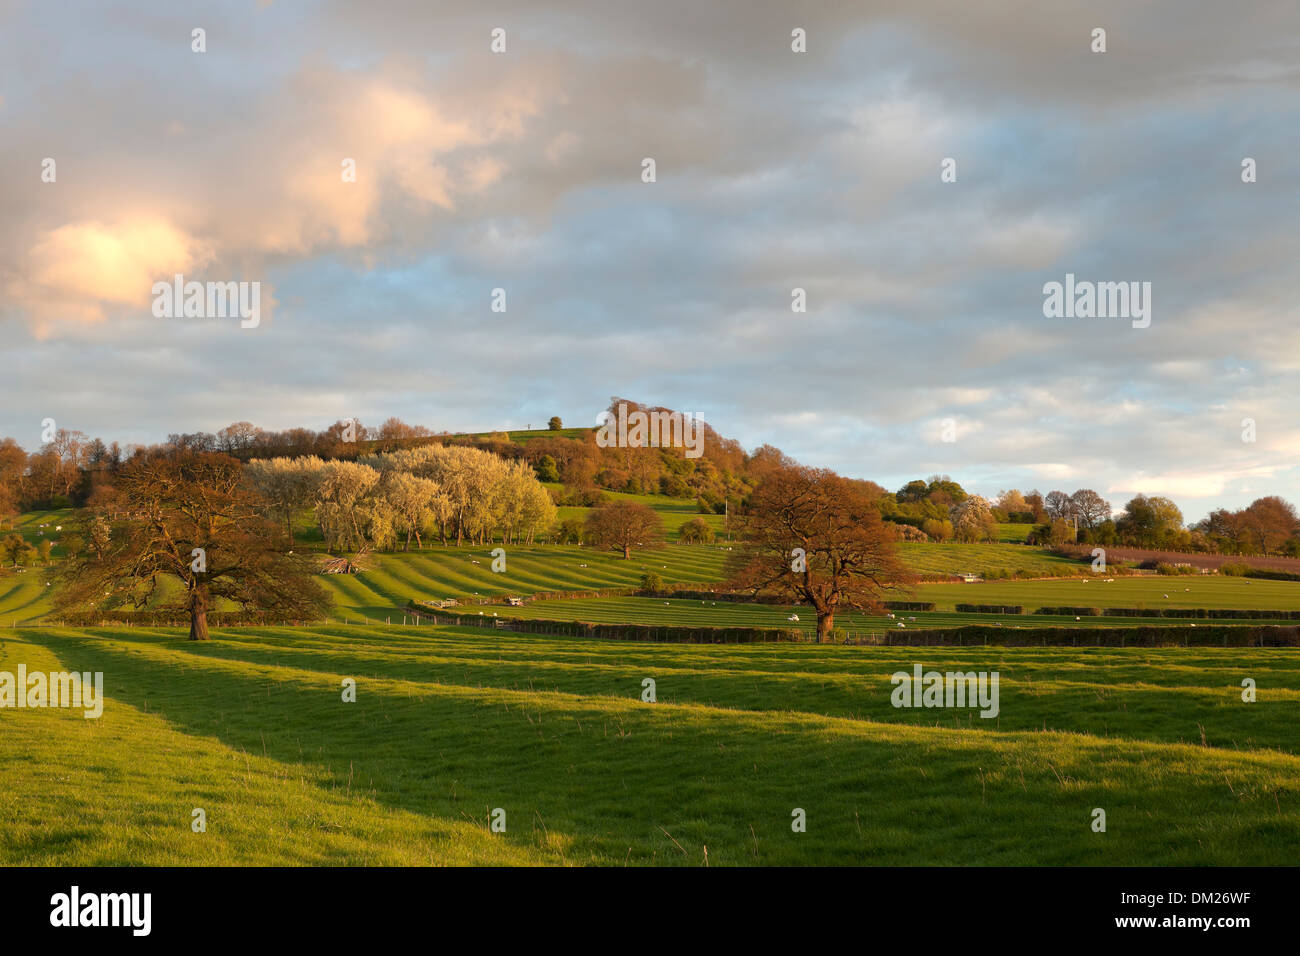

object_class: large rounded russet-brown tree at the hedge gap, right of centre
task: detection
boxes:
[725,464,917,641]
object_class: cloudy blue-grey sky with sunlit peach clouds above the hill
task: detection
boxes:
[0,0,1300,520]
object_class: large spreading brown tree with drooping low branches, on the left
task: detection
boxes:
[60,453,326,641]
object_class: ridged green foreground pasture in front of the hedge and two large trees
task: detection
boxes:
[0,626,1300,866]
